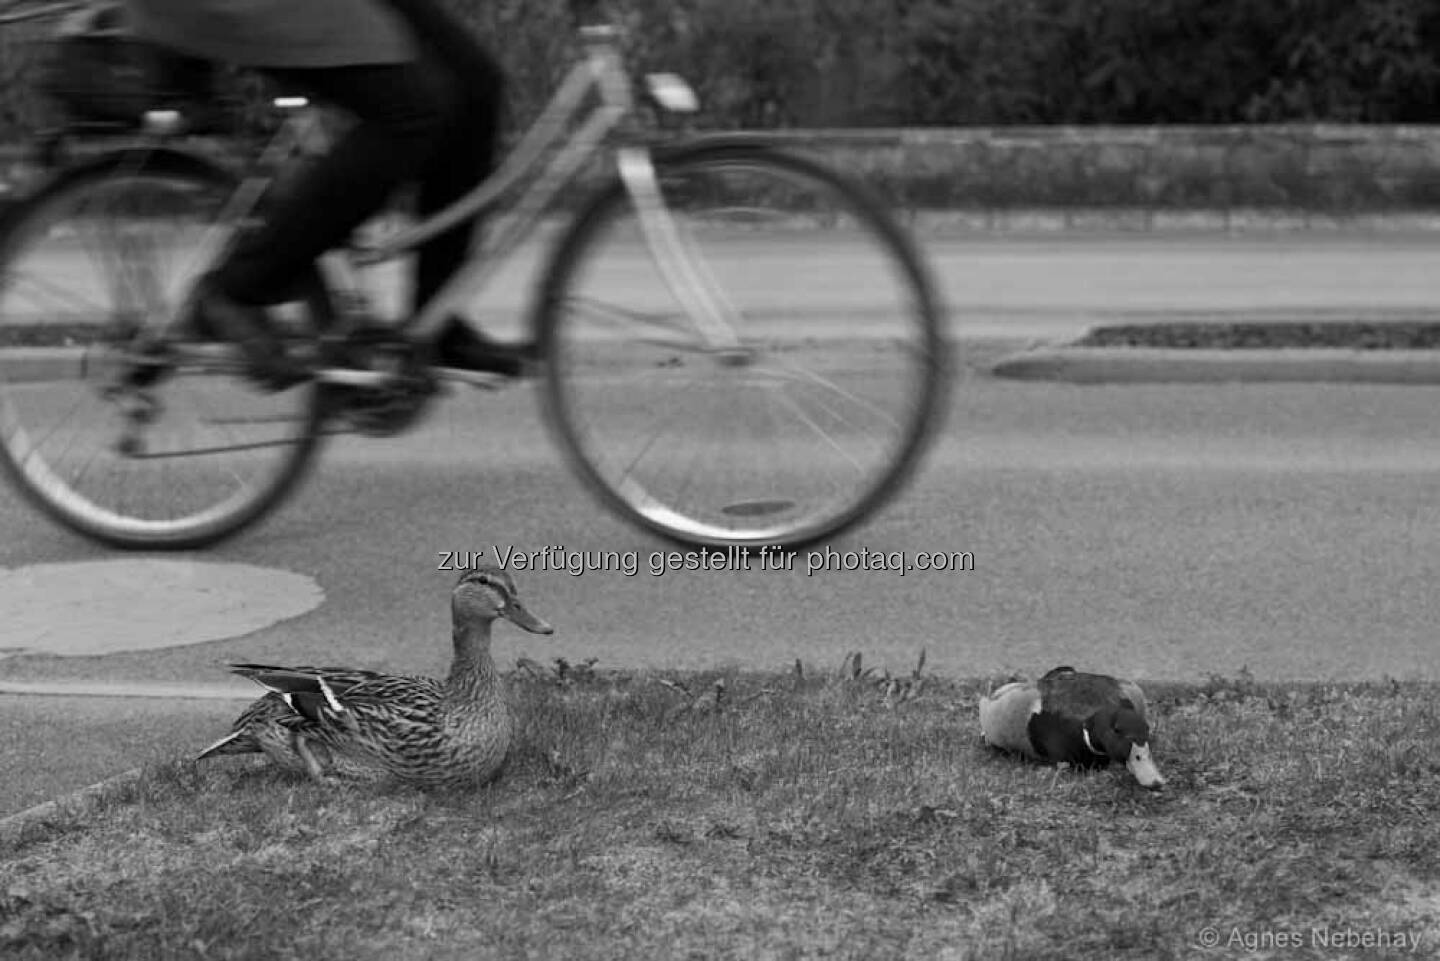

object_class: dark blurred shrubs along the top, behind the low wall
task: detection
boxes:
[0,0,1440,138]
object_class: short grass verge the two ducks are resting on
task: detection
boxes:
[0,657,1440,961]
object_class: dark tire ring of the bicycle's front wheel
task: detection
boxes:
[531,138,950,550]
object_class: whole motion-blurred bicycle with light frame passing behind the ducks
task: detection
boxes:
[0,0,950,549]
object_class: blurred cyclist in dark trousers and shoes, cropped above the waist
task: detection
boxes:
[124,0,524,389]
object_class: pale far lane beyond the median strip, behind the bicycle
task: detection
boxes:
[383,231,1440,337]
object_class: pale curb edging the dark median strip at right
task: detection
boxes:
[989,346,1440,385]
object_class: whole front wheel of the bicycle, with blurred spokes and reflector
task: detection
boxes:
[536,144,949,549]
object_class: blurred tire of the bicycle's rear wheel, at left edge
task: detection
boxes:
[0,148,331,550]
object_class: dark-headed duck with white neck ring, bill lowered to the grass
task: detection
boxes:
[979,666,1165,791]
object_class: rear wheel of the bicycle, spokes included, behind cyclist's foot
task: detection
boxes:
[0,150,328,549]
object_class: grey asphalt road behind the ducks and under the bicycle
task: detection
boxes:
[0,230,1440,811]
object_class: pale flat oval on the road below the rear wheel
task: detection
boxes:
[0,559,325,657]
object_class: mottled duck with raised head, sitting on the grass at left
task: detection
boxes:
[194,565,554,788]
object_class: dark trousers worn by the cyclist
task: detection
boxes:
[216,0,504,310]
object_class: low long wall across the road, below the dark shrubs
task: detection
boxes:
[8,125,1440,225]
